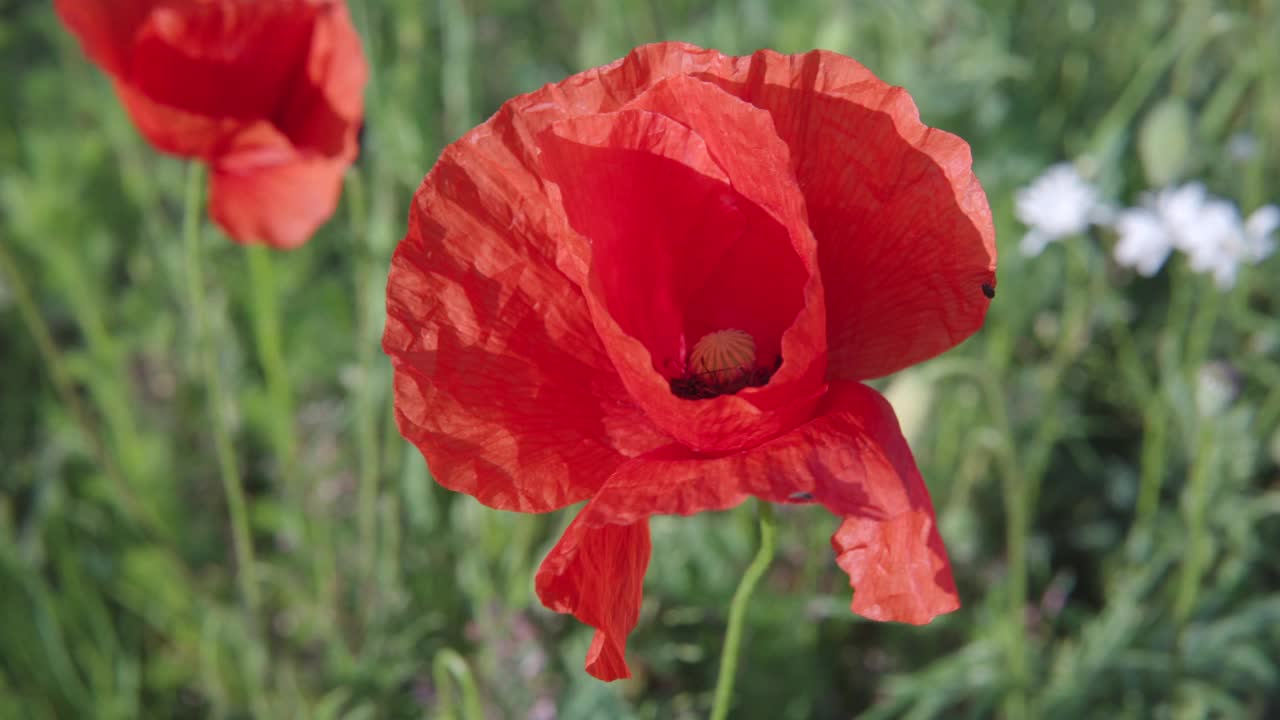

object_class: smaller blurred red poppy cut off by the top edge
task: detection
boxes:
[55,0,369,247]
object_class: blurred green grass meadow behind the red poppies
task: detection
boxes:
[0,0,1280,720]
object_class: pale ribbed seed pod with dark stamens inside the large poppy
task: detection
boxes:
[671,329,776,400]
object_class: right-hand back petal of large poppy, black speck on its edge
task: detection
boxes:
[614,44,996,379]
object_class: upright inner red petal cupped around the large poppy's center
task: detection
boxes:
[540,78,824,452]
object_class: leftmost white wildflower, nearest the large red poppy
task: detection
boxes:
[1014,163,1106,256]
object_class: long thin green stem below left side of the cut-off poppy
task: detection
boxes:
[182,163,257,609]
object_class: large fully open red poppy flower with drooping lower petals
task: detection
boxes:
[383,44,996,680]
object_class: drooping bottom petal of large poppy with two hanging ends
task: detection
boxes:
[538,382,960,676]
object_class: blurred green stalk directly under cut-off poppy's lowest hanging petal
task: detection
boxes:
[246,245,298,489]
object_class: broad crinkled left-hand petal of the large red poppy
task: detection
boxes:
[383,137,669,511]
